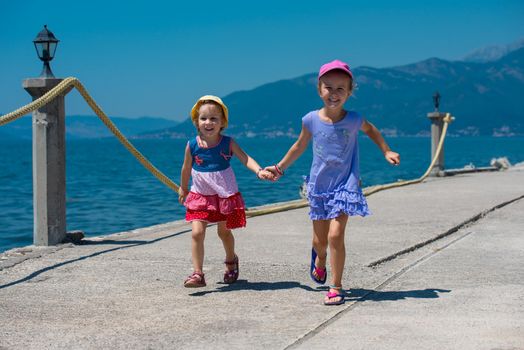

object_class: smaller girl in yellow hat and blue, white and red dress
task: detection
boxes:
[178,95,274,288]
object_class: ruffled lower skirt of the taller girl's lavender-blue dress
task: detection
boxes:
[307,189,371,220]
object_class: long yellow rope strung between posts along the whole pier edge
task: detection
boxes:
[0,77,453,217]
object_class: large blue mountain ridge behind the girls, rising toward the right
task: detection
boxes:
[140,48,524,138]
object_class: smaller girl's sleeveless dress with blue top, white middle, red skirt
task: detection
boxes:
[184,136,246,229]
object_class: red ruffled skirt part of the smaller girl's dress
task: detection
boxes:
[184,192,246,230]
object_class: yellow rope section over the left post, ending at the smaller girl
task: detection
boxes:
[0,77,178,192]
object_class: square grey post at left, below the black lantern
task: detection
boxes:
[23,78,66,246]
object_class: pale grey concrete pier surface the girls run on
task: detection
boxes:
[0,166,524,350]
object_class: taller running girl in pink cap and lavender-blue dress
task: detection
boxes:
[266,60,400,305]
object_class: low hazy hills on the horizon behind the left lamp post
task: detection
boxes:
[0,115,178,139]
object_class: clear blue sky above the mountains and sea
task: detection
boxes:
[0,0,524,120]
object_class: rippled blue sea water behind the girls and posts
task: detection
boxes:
[0,136,524,252]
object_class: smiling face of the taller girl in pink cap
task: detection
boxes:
[318,70,351,109]
